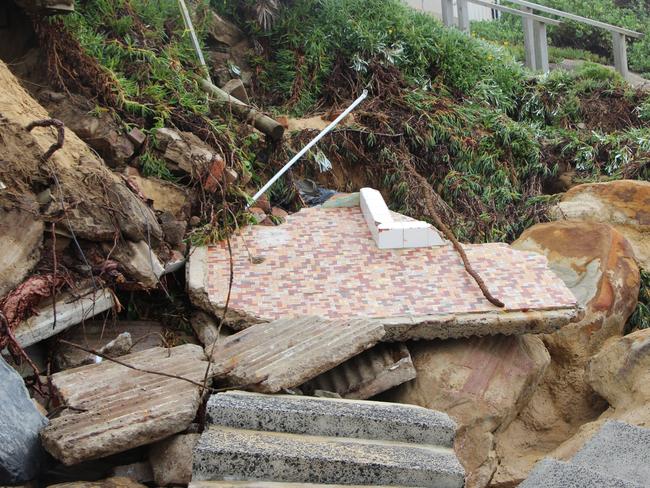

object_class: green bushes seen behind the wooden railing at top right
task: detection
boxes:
[472,0,650,76]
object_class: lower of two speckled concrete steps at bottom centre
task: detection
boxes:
[192,425,464,488]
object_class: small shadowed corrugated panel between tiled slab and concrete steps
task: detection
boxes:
[301,344,416,400]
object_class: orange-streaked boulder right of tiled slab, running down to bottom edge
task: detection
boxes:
[492,221,639,487]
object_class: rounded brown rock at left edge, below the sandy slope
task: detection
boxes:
[0,208,43,298]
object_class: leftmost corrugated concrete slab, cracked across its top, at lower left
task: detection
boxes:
[41,344,208,465]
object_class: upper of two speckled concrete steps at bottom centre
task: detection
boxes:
[207,392,456,447]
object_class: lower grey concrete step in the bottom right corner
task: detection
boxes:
[519,458,648,488]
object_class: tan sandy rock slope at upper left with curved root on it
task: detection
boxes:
[0,62,162,246]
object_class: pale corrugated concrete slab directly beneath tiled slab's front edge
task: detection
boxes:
[206,317,384,393]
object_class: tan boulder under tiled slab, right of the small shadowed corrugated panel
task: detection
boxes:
[387,336,549,488]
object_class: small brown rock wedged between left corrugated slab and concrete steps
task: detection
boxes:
[149,434,201,486]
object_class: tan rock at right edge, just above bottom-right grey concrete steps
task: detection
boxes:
[552,329,650,459]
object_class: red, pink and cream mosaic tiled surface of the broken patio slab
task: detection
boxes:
[201,207,576,322]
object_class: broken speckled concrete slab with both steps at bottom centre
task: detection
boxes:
[192,393,464,488]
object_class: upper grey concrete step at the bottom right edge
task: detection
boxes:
[571,421,650,486]
